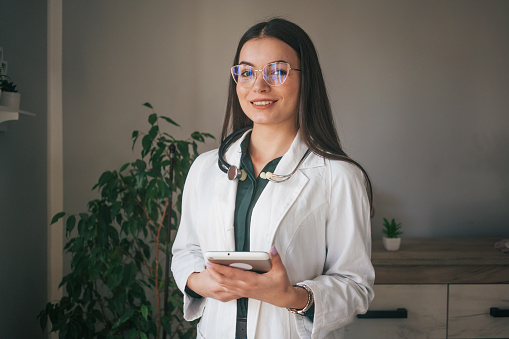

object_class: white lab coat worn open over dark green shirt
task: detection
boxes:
[172,134,375,339]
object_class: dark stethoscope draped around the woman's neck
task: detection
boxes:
[217,127,311,183]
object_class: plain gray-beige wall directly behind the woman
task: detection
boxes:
[64,0,509,237]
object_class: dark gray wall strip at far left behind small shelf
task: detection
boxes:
[0,0,48,338]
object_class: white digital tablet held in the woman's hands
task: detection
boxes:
[205,251,272,273]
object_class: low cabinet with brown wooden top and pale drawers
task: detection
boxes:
[345,238,509,339]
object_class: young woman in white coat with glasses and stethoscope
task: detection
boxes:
[172,19,374,339]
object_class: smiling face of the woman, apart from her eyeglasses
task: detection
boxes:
[237,37,300,129]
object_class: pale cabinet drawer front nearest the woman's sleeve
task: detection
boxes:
[345,284,447,339]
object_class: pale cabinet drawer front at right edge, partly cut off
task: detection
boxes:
[449,284,509,338]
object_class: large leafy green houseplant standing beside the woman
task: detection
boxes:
[39,103,213,338]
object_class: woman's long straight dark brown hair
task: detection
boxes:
[221,18,374,216]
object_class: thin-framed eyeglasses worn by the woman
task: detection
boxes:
[231,62,300,87]
